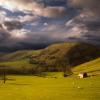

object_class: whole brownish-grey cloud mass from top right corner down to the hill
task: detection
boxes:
[67,0,100,44]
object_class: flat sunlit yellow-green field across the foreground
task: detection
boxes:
[0,76,100,100]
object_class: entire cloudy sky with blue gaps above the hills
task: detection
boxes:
[0,0,100,51]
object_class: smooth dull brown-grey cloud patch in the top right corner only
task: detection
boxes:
[68,0,100,16]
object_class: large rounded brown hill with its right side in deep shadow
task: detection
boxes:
[32,42,100,71]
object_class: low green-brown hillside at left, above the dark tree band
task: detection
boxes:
[0,50,41,69]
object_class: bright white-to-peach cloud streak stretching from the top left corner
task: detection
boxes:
[0,0,66,17]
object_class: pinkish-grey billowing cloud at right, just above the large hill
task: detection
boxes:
[65,11,100,45]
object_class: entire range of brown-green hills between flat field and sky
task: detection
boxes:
[0,42,100,73]
